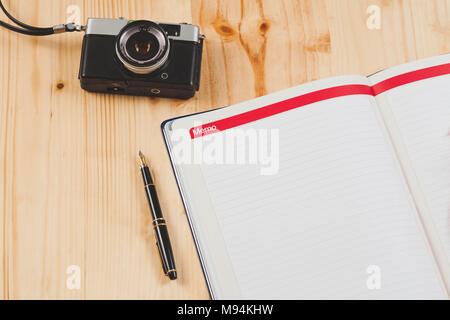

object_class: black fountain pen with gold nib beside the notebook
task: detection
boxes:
[139,151,177,280]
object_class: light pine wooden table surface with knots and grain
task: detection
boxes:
[0,0,450,299]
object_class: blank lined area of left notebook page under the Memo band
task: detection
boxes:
[197,94,442,299]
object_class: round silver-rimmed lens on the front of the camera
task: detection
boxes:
[116,20,170,74]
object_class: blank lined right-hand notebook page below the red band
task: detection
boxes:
[370,69,450,263]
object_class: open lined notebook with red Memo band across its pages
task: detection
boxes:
[162,54,450,299]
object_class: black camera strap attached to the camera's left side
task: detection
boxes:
[0,0,85,36]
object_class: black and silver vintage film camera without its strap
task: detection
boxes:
[79,18,204,99]
